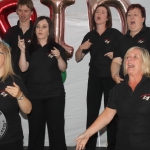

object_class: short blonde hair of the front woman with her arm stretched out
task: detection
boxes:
[123,46,150,77]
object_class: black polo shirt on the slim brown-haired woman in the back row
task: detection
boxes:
[82,28,122,77]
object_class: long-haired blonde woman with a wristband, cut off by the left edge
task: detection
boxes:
[0,42,32,150]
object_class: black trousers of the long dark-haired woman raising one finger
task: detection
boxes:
[28,96,67,150]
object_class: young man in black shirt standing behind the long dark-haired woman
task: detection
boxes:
[3,0,34,83]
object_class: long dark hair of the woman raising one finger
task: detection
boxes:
[31,16,55,45]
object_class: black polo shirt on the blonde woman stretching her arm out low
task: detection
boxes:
[107,76,150,134]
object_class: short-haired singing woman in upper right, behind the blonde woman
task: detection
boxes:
[111,4,150,83]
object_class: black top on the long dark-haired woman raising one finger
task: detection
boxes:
[26,43,67,99]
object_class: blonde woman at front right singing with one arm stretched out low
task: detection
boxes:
[76,47,150,150]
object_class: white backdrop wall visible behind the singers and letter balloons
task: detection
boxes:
[8,0,150,147]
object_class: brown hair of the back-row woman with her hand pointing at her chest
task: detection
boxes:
[92,4,112,29]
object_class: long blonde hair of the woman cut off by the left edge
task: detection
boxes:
[0,41,15,82]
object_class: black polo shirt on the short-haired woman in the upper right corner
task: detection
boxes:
[114,26,150,59]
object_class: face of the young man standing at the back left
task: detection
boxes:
[16,5,33,22]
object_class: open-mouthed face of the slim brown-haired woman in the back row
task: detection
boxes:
[94,6,108,25]
